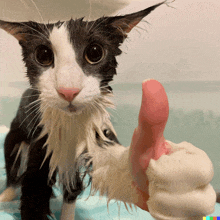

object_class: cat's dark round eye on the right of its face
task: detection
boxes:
[84,44,105,64]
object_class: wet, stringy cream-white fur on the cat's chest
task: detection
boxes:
[40,96,113,185]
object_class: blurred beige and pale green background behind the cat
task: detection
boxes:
[0,0,220,190]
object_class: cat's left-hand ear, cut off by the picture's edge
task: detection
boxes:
[0,20,25,41]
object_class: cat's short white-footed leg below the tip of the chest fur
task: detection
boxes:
[61,172,84,220]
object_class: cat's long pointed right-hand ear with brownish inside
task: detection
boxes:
[111,1,166,35]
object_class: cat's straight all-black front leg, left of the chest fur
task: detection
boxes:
[21,136,53,220]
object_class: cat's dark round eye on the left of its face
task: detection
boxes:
[35,45,54,66]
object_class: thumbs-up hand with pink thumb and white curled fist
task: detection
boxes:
[129,80,215,219]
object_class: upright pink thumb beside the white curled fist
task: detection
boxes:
[130,79,170,191]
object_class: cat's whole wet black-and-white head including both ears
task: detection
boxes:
[0,2,164,112]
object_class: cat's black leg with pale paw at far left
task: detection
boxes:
[0,126,24,202]
